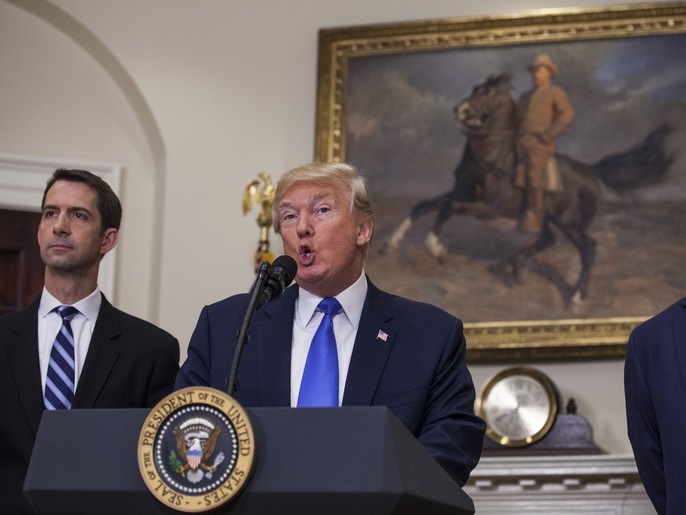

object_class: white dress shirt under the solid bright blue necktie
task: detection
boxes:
[291,270,367,407]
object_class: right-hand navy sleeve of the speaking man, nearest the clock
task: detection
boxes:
[418,320,486,485]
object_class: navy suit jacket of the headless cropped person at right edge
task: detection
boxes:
[624,298,686,515]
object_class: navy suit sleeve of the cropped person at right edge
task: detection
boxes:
[624,327,676,513]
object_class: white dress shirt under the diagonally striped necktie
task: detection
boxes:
[38,288,102,398]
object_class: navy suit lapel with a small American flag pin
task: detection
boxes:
[343,279,397,406]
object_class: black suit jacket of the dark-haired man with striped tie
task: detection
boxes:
[0,295,179,514]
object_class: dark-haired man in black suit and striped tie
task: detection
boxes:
[0,169,179,515]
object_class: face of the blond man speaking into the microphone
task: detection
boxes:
[278,183,372,297]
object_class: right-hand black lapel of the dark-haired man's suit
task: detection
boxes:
[73,295,120,408]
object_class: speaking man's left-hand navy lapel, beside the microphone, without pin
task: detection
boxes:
[249,285,298,406]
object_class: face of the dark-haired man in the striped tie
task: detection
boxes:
[38,181,117,272]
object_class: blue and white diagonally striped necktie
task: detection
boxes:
[45,306,79,410]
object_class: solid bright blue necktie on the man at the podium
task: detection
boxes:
[298,297,341,408]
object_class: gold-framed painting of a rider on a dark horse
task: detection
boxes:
[316,3,686,362]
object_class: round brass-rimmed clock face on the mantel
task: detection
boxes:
[477,368,557,447]
